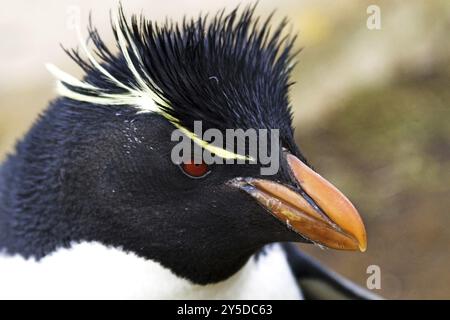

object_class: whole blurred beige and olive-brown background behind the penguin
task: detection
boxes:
[0,0,450,299]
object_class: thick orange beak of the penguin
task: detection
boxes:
[233,154,367,252]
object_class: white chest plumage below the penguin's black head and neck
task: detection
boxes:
[0,243,302,299]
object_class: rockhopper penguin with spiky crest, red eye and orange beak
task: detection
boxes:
[0,6,376,300]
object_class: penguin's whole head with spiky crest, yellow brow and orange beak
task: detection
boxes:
[14,8,366,283]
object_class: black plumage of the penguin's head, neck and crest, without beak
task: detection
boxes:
[0,7,374,298]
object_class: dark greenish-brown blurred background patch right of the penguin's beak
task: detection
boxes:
[298,60,450,299]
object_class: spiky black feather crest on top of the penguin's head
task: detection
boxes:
[61,6,295,139]
